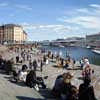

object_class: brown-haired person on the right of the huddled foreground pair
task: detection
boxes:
[61,72,78,100]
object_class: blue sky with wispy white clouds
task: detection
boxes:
[0,0,100,41]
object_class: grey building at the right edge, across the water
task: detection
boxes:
[86,32,100,47]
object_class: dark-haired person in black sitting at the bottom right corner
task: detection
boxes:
[79,77,96,100]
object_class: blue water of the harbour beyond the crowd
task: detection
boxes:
[43,46,100,65]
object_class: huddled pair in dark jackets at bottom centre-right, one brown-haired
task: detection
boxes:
[52,72,78,100]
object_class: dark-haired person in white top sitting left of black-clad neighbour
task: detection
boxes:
[18,65,28,82]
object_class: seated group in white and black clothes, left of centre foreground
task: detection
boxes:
[14,65,46,91]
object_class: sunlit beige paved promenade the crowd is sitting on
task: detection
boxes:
[0,45,100,100]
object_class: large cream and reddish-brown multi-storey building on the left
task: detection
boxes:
[0,24,27,44]
